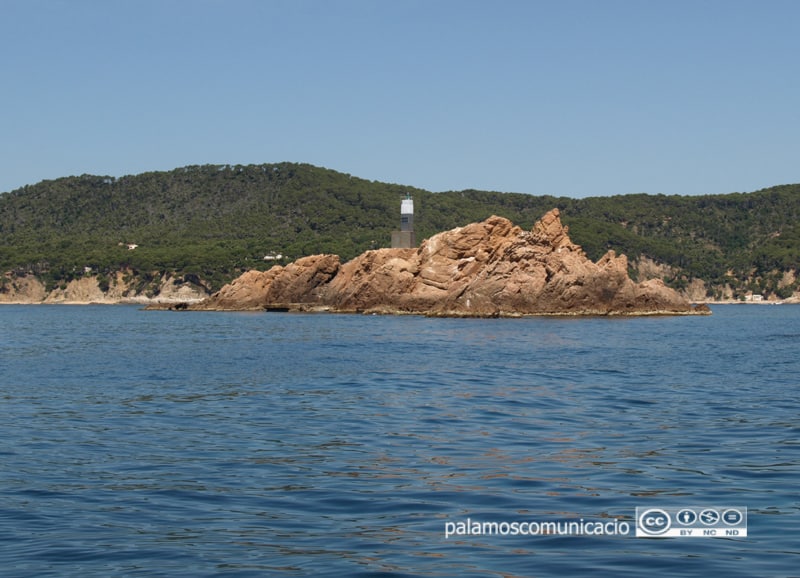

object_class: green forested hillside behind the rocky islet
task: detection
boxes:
[0,163,800,297]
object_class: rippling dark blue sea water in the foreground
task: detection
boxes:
[0,305,800,578]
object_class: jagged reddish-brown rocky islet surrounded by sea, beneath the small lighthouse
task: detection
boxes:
[189,209,708,317]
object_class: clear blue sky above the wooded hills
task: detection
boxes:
[0,0,800,197]
